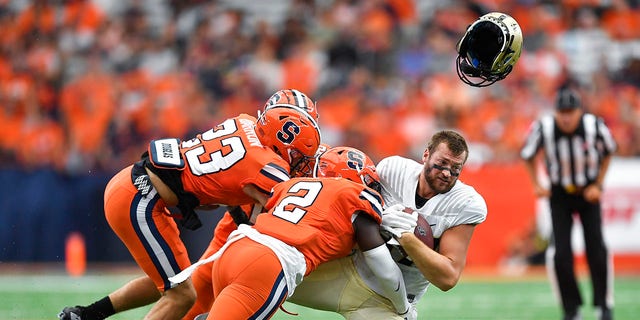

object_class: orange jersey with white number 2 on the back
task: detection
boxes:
[254,178,382,274]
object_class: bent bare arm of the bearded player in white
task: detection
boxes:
[398,224,475,291]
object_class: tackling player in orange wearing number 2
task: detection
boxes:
[170,147,411,319]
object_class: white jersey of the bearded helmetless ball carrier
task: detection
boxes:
[355,156,487,302]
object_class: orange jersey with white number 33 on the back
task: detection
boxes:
[174,114,289,205]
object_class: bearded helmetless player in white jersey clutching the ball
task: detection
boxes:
[289,130,487,320]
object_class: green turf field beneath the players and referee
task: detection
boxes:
[0,272,640,320]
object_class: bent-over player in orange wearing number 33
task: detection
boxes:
[59,92,320,319]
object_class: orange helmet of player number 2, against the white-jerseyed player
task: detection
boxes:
[313,147,382,193]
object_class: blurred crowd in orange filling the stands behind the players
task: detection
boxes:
[0,0,640,174]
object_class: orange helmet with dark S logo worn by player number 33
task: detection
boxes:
[256,107,320,176]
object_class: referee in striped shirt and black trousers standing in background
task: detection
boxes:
[520,87,617,320]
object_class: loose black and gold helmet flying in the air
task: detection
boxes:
[456,12,523,87]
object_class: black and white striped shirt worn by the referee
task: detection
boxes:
[520,113,617,188]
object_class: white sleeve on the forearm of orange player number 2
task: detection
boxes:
[362,244,409,314]
